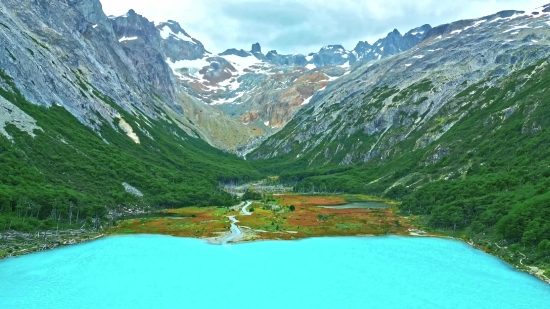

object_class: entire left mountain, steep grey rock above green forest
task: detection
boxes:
[0,0,261,221]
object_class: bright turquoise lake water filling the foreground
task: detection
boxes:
[0,235,550,309]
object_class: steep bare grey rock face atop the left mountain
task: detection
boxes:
[0,1,156,130]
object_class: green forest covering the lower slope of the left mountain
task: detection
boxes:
[0,71,261,231]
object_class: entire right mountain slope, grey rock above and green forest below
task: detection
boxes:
[251,5,550,260]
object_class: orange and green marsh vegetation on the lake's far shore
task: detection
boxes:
[111,195,414,241]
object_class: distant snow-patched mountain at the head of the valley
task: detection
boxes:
[157,22,431,141]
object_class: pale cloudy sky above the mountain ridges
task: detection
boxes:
[101,0,550,54]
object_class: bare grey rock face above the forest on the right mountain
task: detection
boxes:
[251,8,550,162]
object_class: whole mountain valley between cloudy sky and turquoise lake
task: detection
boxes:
[0,0,550,298]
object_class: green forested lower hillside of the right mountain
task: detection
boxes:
[255,56,550,262]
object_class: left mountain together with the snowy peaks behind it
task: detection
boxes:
[0,0,436,230]
